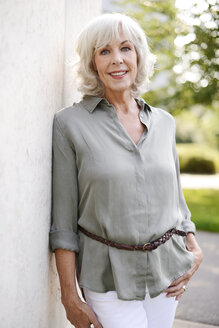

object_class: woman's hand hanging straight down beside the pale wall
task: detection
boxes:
[62,297,103,328]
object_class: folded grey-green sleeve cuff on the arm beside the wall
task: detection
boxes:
[49,231,79,253]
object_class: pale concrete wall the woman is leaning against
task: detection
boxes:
[0,0,101,328]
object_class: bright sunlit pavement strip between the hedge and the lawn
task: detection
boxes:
[181,173,219,189]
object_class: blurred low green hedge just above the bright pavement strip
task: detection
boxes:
[177,144,219,174]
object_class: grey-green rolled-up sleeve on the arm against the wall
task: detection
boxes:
[49,114,79,252]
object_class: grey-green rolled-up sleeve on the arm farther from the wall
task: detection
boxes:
[173,121,196,234]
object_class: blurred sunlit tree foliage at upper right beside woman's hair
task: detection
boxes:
[117,0,219,114]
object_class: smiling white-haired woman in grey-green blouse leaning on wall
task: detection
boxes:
[50,14,202,328]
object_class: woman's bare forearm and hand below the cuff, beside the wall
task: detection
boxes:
[55,248,103,328]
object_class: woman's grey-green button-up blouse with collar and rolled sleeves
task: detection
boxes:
[49,96,195,300]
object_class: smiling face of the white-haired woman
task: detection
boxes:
[94,33,137,95]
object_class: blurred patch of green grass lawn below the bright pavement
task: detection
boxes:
[183,189,219,232]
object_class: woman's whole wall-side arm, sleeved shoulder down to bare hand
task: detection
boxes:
[49,116,102,328]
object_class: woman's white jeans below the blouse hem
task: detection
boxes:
[84,288,178,328]
